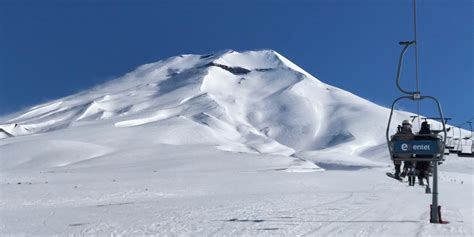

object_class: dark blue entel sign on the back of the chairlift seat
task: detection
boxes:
[394,141,440,155]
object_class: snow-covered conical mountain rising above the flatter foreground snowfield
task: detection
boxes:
[0,50,408,162]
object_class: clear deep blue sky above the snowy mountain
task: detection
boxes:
[0,0,474,124]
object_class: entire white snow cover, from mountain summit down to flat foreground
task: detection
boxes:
[0,50,474,236]
